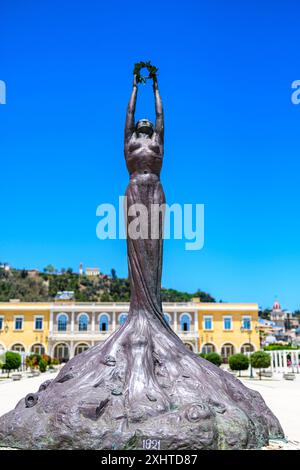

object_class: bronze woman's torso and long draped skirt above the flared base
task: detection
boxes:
[125,135,166,326]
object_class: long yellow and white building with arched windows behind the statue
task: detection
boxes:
[0,301,260,361]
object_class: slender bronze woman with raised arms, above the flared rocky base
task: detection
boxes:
[124,75,165,322]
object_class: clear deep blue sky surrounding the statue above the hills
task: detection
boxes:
[0,0,300,309]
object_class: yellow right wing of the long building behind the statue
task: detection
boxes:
[197,303,260,362]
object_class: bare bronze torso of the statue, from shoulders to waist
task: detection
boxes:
[125,133,163,176]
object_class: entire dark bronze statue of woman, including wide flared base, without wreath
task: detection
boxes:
[0,64,283,450]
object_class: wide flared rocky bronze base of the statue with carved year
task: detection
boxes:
[0,312,283,450]
